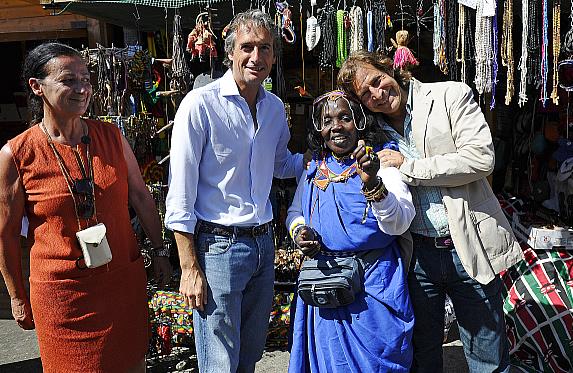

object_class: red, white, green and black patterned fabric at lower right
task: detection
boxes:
[502,244,573,373]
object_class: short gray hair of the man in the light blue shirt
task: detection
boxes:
[223,9,281,68]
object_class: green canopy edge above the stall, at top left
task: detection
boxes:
[56,0,252,31]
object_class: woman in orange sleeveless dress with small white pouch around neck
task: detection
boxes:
[0,43,171,373]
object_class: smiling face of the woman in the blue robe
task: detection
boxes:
[320,97,358,156]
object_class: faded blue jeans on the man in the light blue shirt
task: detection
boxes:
[193,230,275,373]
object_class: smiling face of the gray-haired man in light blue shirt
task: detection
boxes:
[229,26,275,94]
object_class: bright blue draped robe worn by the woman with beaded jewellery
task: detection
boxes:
[289,156,414,373]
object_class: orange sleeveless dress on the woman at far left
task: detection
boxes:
[8,120,148,373]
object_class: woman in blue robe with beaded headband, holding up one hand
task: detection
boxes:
[287,91,415,373]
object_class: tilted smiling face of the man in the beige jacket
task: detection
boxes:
[353,63,406,116]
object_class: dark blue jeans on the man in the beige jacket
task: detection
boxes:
[408,238,509,373]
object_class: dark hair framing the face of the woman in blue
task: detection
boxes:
[307,96,388,153]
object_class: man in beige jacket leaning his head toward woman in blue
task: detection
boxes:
[338,51,522,373]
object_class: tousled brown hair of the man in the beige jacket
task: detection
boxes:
[337,49,412,95]
